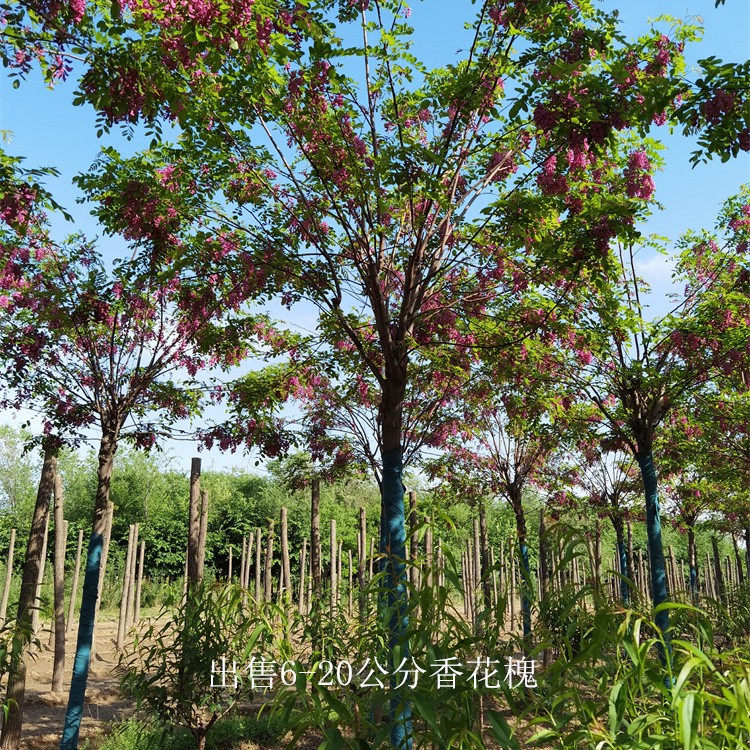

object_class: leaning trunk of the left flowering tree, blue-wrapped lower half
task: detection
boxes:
[60,430,118,750]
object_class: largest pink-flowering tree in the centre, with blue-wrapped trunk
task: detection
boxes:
[76,0,704,745]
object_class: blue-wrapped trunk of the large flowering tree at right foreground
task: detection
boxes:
[637,450,671,665]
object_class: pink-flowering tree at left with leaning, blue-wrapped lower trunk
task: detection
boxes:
[0,228,247,747]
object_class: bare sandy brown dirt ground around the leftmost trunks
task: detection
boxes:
[21,620,133,750]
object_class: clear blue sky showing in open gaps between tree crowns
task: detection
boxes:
[0,0,750,476]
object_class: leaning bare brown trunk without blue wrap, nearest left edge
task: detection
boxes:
[0,444,57,750]
